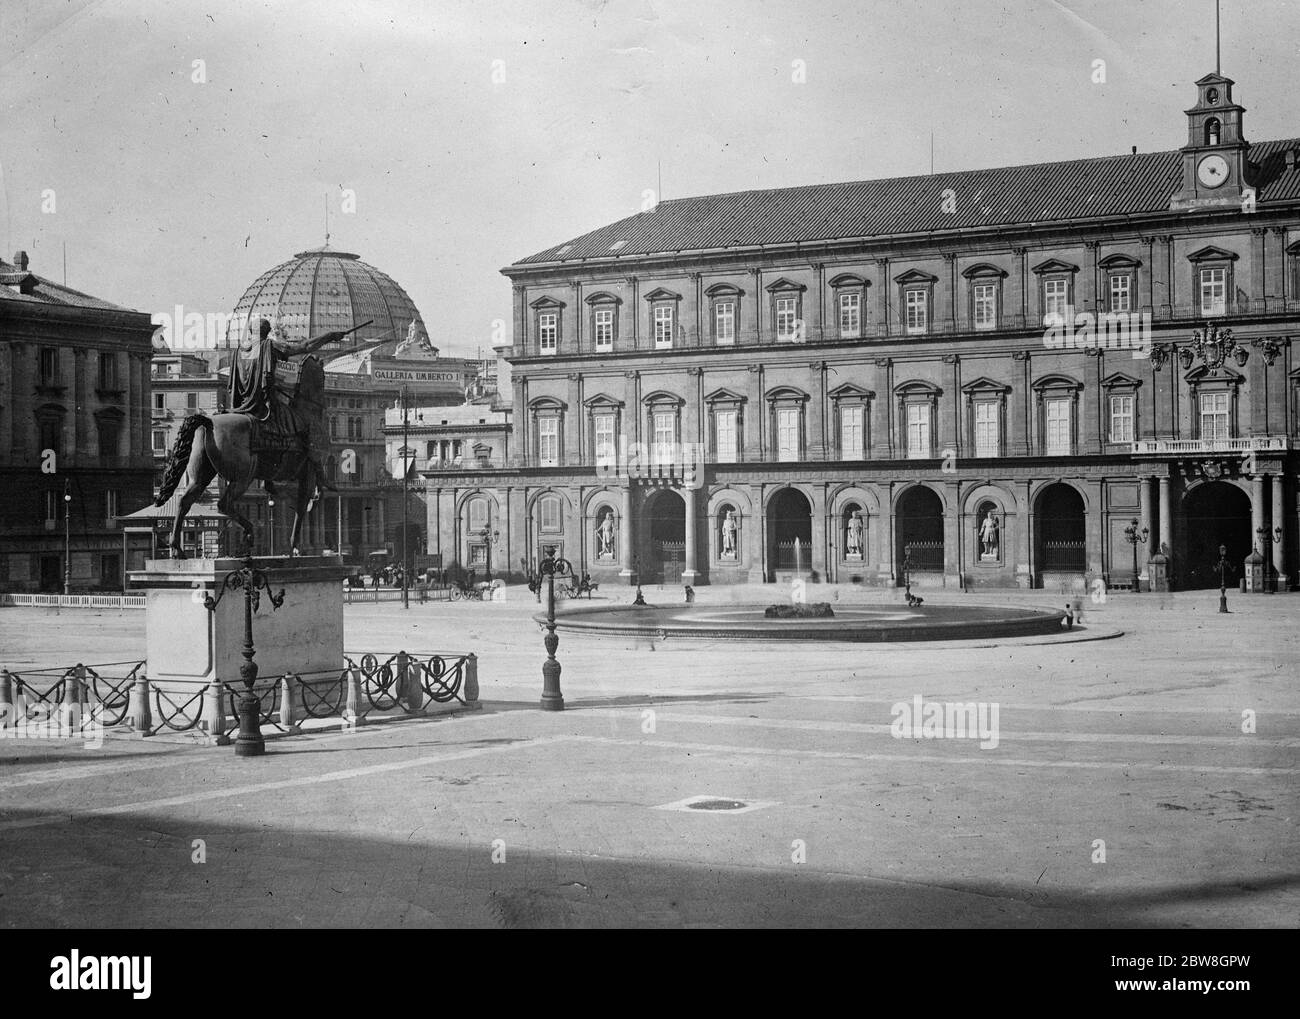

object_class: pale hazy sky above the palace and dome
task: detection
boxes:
[0,0,1300,356]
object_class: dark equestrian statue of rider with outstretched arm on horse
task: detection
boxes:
[155,318,369,559]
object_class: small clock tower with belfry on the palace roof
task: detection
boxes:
[1169,73,1253,209]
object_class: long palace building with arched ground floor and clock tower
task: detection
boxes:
[421,74,1300,590]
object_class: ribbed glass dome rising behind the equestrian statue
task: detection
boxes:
[226,244,428,354]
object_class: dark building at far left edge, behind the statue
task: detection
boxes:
[0,251,153,591]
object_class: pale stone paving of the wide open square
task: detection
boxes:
[0,577,1300,928]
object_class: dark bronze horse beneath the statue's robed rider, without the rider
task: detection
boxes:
[155,357,337,559]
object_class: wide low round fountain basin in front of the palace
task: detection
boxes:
[536,604,1065,643]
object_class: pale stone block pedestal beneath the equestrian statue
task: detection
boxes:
[130,556,348,742]
